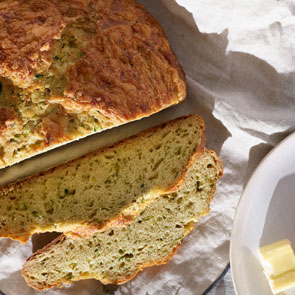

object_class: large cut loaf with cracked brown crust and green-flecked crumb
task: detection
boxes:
[0,0,186,168]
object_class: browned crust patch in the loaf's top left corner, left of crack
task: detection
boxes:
[0,0,65,85]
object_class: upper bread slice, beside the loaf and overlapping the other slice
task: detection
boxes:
[0,115,205,242]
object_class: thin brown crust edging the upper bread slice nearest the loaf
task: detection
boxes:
[0,114,205,243]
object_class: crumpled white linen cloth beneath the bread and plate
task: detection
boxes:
[0,0,295,295]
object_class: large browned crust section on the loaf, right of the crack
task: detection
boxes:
[66,1,185,122]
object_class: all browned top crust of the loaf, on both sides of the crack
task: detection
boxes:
[0,0,185,121]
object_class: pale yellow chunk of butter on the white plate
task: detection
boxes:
[259,239,295,294]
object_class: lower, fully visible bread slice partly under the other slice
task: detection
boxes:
[22,151,222,291]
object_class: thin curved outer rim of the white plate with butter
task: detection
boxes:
[229,131,295,295]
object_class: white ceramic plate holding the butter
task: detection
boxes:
[230,133,295,295]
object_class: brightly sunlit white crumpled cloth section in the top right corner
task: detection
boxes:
[177,0,295,73]
